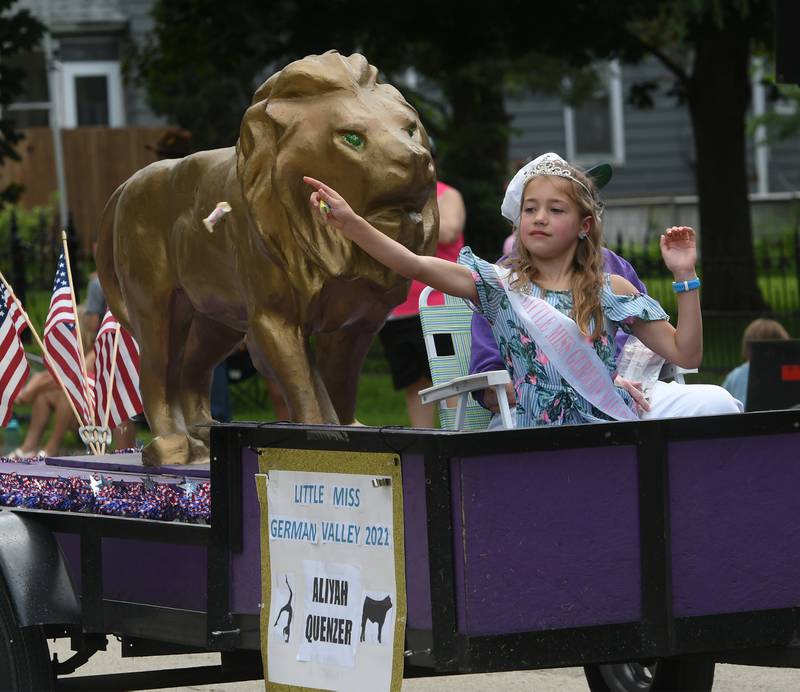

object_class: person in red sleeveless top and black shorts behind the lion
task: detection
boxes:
[379,143,467,428]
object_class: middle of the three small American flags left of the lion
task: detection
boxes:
[44,253,94,425]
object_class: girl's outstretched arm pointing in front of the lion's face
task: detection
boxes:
[303,176,478,302]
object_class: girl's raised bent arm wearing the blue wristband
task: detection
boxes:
[611,226,703,368]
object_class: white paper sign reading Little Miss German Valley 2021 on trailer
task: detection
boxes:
[266,469,397,692]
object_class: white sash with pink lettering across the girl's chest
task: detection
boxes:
[493,265,639,420]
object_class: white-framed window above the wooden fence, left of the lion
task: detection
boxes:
[62,60,125,127]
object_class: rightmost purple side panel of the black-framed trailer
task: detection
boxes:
[669,434,800,617]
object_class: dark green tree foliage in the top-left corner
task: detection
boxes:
[0,0,44,209]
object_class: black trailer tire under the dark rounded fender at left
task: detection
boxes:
[0,579,55,692]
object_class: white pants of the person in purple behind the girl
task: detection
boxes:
[488,380,744,430]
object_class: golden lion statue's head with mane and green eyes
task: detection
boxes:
[237,53,438,289]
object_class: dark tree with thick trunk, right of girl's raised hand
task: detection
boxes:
[626,0,774,311]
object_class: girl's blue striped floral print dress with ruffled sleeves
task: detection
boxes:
[458,247,669,428]
